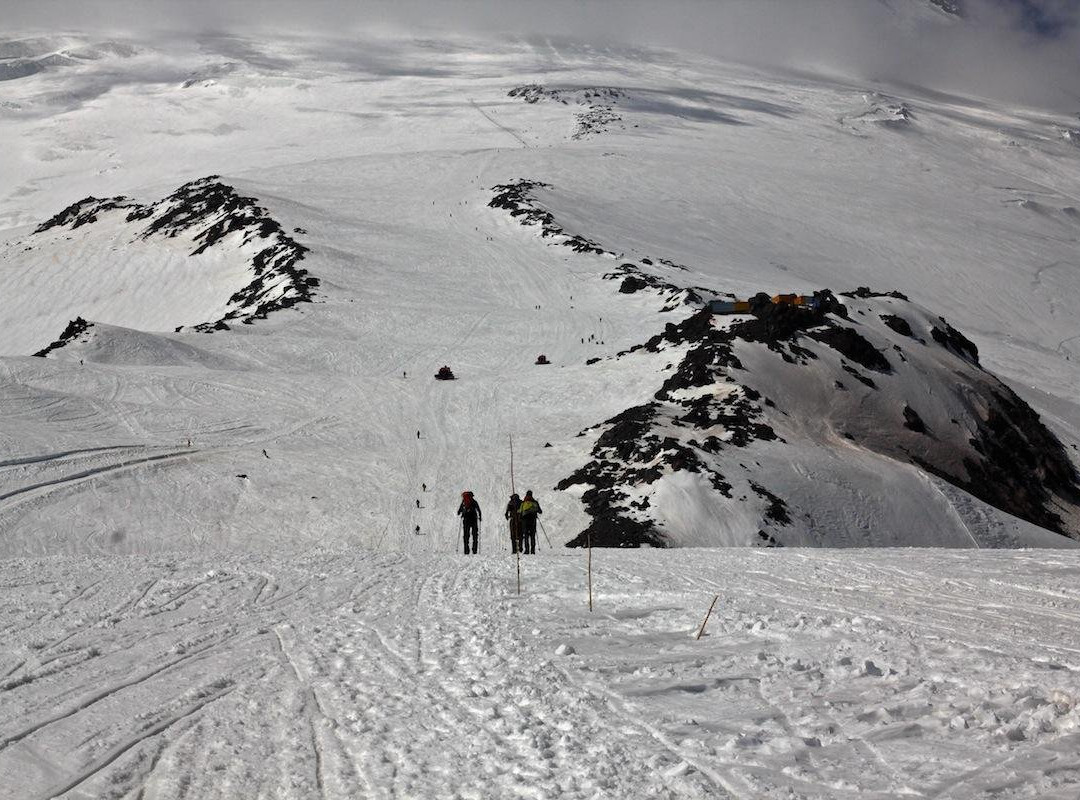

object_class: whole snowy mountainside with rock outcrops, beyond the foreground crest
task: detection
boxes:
[0,31,1080,554]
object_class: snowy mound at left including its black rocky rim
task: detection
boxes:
[0,176,319,353]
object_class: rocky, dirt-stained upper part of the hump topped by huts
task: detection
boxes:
[556,288,1080,546]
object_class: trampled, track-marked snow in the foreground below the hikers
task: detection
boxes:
[0,548,1080,800]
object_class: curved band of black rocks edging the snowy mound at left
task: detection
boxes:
[35,175,319,331]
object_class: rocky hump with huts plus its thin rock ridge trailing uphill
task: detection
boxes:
[489,179,1080,546]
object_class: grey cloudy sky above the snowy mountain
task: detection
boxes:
[6,0,1080,112]
